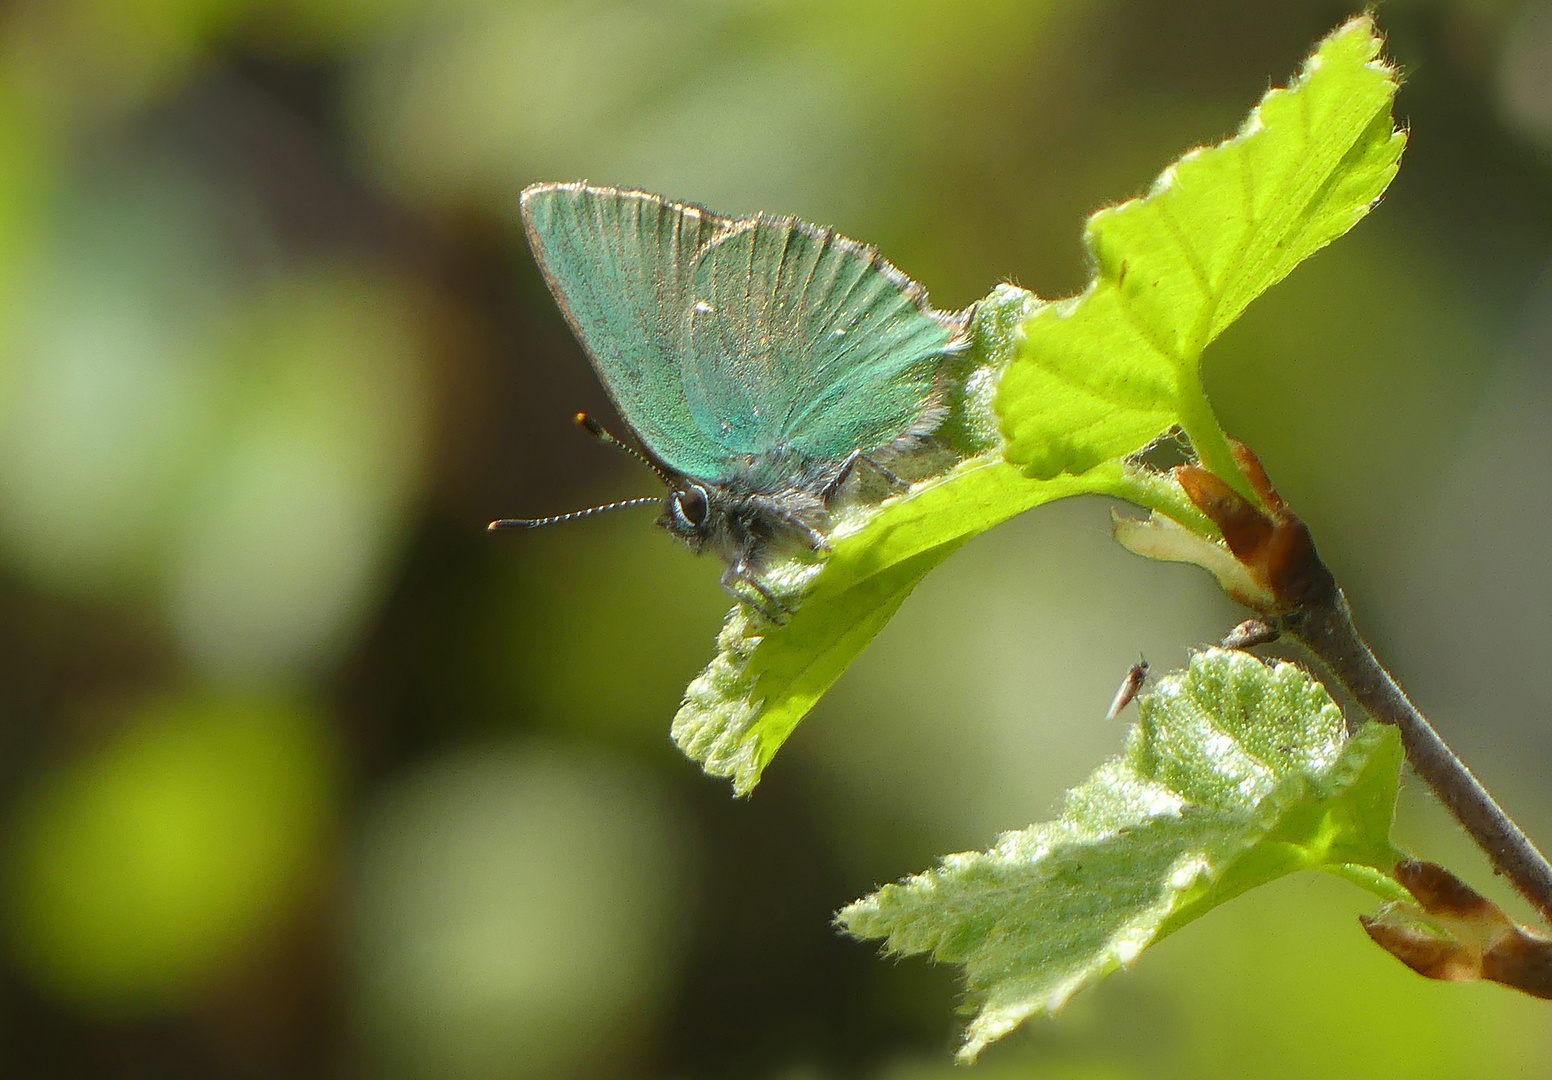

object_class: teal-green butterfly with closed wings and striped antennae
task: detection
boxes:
[490,183,968,621]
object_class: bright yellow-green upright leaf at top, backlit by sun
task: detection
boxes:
[996,16,1406,493]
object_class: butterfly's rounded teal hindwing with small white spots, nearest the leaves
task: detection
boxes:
[684,216,958,462]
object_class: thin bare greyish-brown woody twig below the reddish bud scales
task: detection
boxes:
[1279,588,1552,923]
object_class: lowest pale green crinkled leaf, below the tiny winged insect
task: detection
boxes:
[838,649,1405,1058]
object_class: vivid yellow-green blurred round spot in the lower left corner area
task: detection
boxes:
[5,698,337,1015]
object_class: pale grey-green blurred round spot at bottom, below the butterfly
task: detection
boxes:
[355,746,694,1080]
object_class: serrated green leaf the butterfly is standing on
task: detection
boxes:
[672,286,1212,794]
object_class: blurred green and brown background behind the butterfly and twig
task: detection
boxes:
[0,0,1552,1080]
